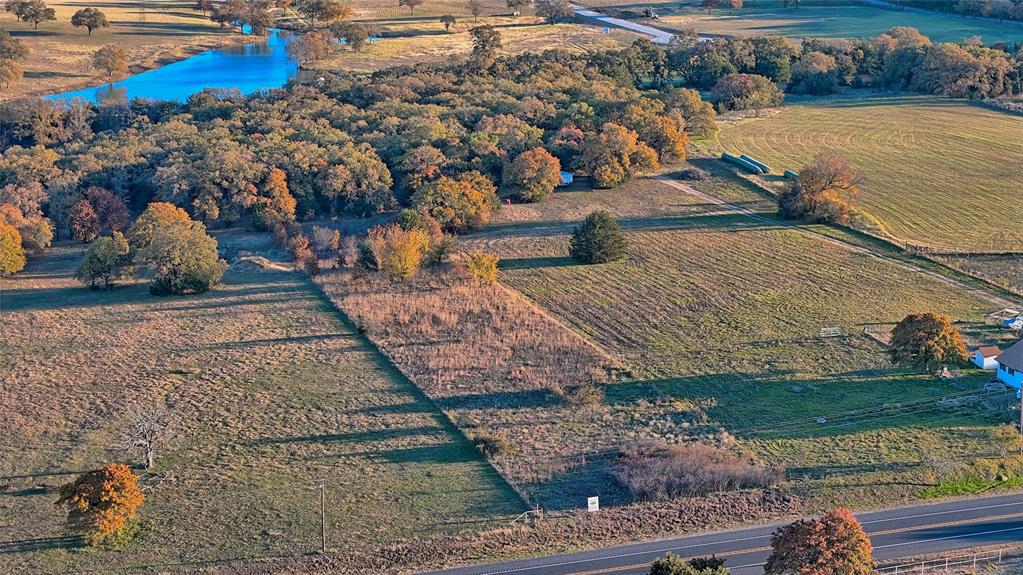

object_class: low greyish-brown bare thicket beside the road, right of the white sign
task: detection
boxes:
[611,444,782,500]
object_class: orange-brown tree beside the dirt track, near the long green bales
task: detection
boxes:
[777,151,859,224]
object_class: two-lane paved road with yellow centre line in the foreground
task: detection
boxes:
[425,493,1023,575]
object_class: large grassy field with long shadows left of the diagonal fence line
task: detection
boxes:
[0,233,523,573]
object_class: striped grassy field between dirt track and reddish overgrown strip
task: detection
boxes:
[488,215,1009,505]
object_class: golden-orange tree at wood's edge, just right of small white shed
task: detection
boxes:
[579,122,659,187]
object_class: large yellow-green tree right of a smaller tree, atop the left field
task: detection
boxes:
[128,202,227,296]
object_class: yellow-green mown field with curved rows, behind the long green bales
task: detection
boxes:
[720,98,1023,252]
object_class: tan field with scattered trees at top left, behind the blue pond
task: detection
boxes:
[0,0,247,98]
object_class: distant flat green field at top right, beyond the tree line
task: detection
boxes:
[642,0,1023,42]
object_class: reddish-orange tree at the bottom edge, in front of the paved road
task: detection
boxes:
[764,508,874,575]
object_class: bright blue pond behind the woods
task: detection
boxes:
[47,31,298,103]
